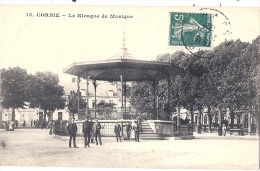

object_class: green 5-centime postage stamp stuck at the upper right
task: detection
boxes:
[169,12,212,47]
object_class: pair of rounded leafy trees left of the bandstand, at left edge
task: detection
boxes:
[1,67,65,119]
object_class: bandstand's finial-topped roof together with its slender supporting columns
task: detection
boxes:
[64,34,182,119]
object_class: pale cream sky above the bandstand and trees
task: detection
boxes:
[0,5,260,90]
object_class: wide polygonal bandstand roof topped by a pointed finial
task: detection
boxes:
[64,36,182,81]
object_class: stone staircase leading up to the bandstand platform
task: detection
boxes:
[139,121,161,140]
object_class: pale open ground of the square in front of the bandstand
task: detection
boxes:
[0,129,259,169]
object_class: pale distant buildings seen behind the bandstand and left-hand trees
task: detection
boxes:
[2,81,135,124]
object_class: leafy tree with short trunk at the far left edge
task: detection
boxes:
[1,67,27,120]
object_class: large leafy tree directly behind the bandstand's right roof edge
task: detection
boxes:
[158,51,206,132]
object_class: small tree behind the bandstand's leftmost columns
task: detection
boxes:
[68,91,86,117]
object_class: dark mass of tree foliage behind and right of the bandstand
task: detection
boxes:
[130,36,260,127]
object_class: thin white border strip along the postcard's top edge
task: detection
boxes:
[0,0,260,7]
